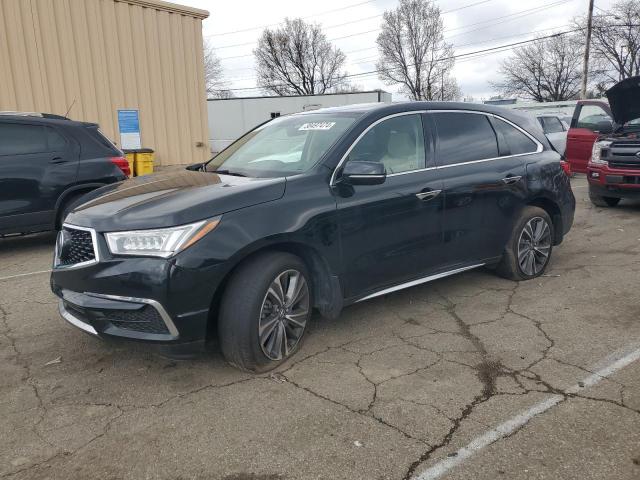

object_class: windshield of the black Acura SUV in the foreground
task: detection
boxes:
[206,114,356,177]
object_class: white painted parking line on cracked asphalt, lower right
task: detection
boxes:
[414,348,640,480]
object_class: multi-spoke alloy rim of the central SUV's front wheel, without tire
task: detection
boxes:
[258,270,311,360]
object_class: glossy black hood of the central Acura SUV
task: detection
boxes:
[66,170,286,232]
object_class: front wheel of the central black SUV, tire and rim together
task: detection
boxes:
[218,252,313,373]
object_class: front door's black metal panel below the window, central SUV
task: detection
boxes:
[337,174,444,298]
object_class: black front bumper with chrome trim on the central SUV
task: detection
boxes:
[51,226,230,345]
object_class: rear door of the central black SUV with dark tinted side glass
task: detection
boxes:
[430,112,537,267]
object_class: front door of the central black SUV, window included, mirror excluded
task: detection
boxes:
[334,113,443,298]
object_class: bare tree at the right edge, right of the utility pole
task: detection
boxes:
[578,0,640,86]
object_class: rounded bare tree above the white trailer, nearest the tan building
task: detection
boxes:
[253,18,346,95]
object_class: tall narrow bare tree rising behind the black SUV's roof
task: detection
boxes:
[377,0,460,100]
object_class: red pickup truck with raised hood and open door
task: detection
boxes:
[566,76,640,207]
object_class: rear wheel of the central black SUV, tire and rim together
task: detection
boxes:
[496,206,555,281]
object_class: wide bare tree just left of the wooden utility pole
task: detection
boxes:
[492,35,582,102]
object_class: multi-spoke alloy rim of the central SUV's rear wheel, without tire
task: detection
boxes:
[518,217,551,276]
